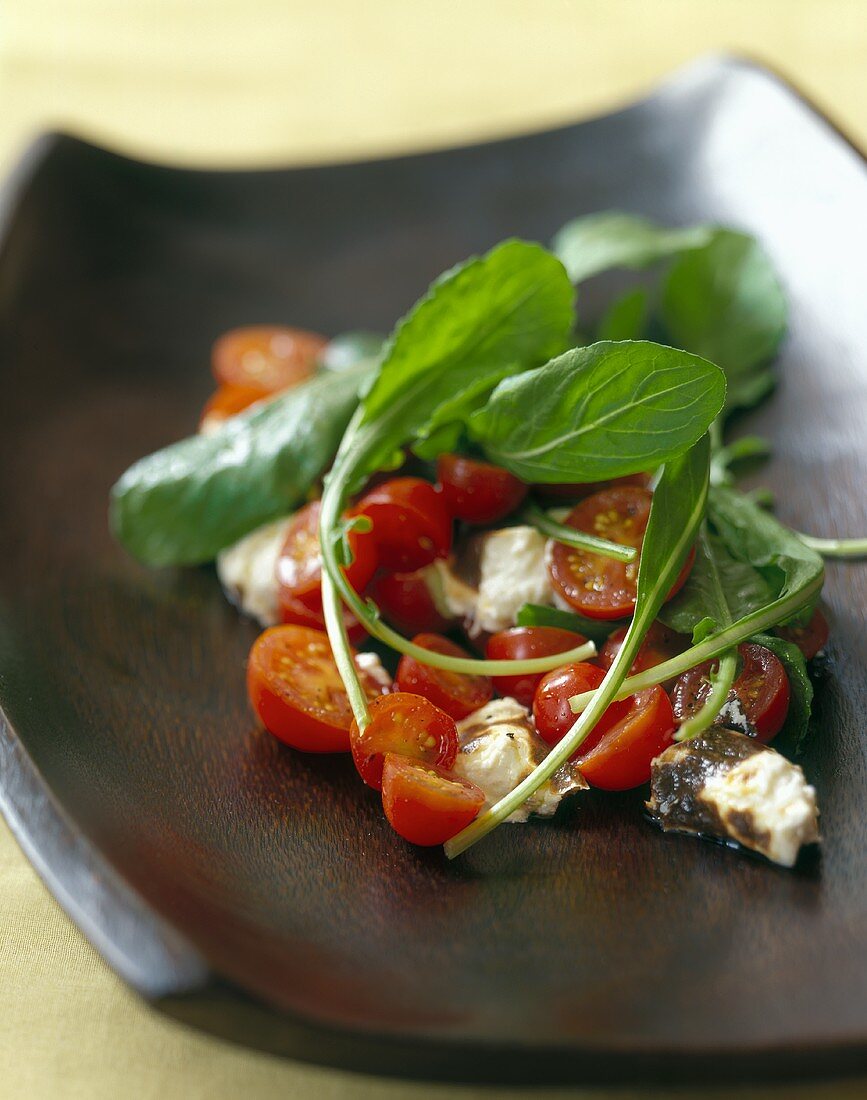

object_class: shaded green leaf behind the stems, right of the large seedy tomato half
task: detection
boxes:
[659,530,773,645]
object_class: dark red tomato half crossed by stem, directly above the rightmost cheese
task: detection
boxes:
[671,641,790,741]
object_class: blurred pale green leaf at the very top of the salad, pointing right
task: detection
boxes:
[551,210,713,283]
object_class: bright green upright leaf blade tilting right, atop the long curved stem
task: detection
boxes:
[359,240,574,469]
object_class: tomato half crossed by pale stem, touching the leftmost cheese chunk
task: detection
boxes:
[276,501,376,611]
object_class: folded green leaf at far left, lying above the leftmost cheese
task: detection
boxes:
[110,363,373,565]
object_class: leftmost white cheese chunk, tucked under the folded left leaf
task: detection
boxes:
[217,516,292,626]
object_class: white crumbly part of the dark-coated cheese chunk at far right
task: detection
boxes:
[700,749,819,867]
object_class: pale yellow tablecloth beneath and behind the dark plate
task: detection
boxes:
[0,0,867,1100]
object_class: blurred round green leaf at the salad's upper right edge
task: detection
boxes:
[661,229,787,409]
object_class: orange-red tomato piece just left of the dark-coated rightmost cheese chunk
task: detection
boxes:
[574,684,674,791]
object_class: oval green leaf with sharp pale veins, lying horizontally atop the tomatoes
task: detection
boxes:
[470,340,725,482]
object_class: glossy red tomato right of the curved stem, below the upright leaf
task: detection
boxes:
[355,477,451,573]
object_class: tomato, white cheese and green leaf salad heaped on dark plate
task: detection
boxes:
[111,212,867,867]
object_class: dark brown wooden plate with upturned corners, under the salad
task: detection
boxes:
[0,61,867,1082]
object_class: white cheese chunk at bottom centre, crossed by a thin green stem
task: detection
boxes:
[454,699,586,822]
